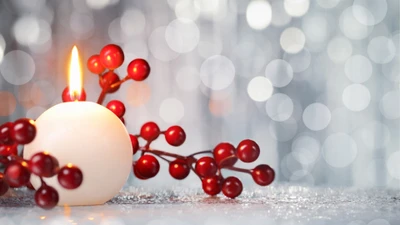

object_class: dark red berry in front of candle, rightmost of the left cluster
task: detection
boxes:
[57,163,83,189]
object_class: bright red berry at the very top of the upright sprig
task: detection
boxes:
[100,44,124,70]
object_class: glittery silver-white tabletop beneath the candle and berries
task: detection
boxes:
[0,186,400,225]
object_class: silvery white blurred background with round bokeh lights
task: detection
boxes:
[0,0,400,188]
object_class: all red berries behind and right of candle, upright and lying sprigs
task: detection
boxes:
[77,44,275,198]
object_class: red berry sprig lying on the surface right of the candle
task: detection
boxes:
[130,122,275,198]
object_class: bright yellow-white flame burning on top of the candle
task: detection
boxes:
[68,45,83,99]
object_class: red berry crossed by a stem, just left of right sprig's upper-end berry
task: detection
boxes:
[213,142,237,167]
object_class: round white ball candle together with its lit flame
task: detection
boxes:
[24,47,132,205]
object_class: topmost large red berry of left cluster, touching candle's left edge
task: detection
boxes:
[10,118,36,144]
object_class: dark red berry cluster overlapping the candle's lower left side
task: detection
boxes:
[0,118,83,209]
